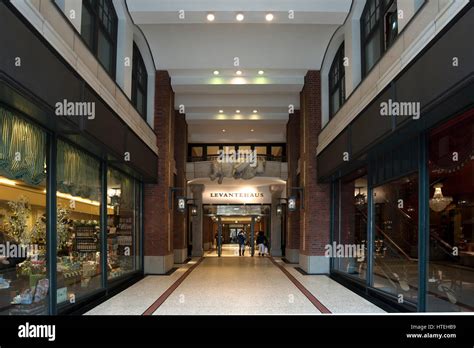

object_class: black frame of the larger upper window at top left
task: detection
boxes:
[81,0,118,81]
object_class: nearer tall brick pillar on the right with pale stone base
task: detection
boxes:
[299,71,330,274]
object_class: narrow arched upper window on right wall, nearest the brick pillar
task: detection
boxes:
[329,43,346,118]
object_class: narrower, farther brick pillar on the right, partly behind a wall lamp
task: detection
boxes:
[285,110,300,263]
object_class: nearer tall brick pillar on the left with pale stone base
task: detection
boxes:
[143,71,174,274]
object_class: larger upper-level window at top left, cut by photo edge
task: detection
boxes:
[81,0,117,79]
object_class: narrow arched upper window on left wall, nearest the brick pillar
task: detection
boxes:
[132,43,148,119]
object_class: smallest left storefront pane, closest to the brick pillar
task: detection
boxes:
[107,169,140,279]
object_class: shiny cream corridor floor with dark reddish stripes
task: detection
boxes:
[86,246,383,315]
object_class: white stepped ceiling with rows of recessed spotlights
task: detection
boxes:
[127,0,352,142]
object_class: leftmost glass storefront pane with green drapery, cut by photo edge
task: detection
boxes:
[0,108,50,315]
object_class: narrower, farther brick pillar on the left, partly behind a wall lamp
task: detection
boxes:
[173,111,188,263]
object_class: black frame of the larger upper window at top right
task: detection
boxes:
[360,0,399,78]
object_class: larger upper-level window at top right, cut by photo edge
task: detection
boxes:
[361,0,398,76]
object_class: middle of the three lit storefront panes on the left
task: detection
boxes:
[56,140,101,306]
